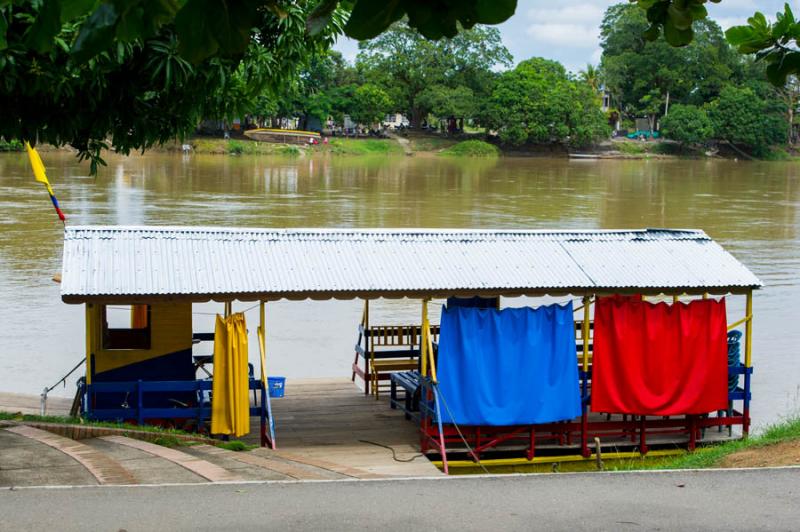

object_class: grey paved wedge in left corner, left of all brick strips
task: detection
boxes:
[0,425,97,488]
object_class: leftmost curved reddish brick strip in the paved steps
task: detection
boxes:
[3,425,136,485]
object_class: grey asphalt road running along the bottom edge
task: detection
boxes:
[0,468,800,532]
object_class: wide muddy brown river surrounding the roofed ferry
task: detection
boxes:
[0,152,800,427]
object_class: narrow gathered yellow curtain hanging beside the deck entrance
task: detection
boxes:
[211,313,250,437]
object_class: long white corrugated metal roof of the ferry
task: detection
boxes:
[61,226,761,302]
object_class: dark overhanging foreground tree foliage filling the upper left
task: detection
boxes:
[0,0,516,171]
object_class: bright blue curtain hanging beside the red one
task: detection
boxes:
[437,303,581,426]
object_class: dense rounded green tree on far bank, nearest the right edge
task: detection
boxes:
[708,86,786,157]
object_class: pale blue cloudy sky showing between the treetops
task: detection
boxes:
[334,0,800,72]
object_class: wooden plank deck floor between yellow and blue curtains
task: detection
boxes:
[247,377,442,478]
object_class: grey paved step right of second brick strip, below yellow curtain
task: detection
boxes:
[186,445,348,480]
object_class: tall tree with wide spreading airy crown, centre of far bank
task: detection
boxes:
[356,24,511,127]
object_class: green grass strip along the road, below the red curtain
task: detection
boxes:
[610,416,800,470]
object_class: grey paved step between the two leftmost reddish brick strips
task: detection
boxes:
[81,438,208,484]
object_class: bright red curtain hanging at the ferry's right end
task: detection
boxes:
[592,297,728,416]
